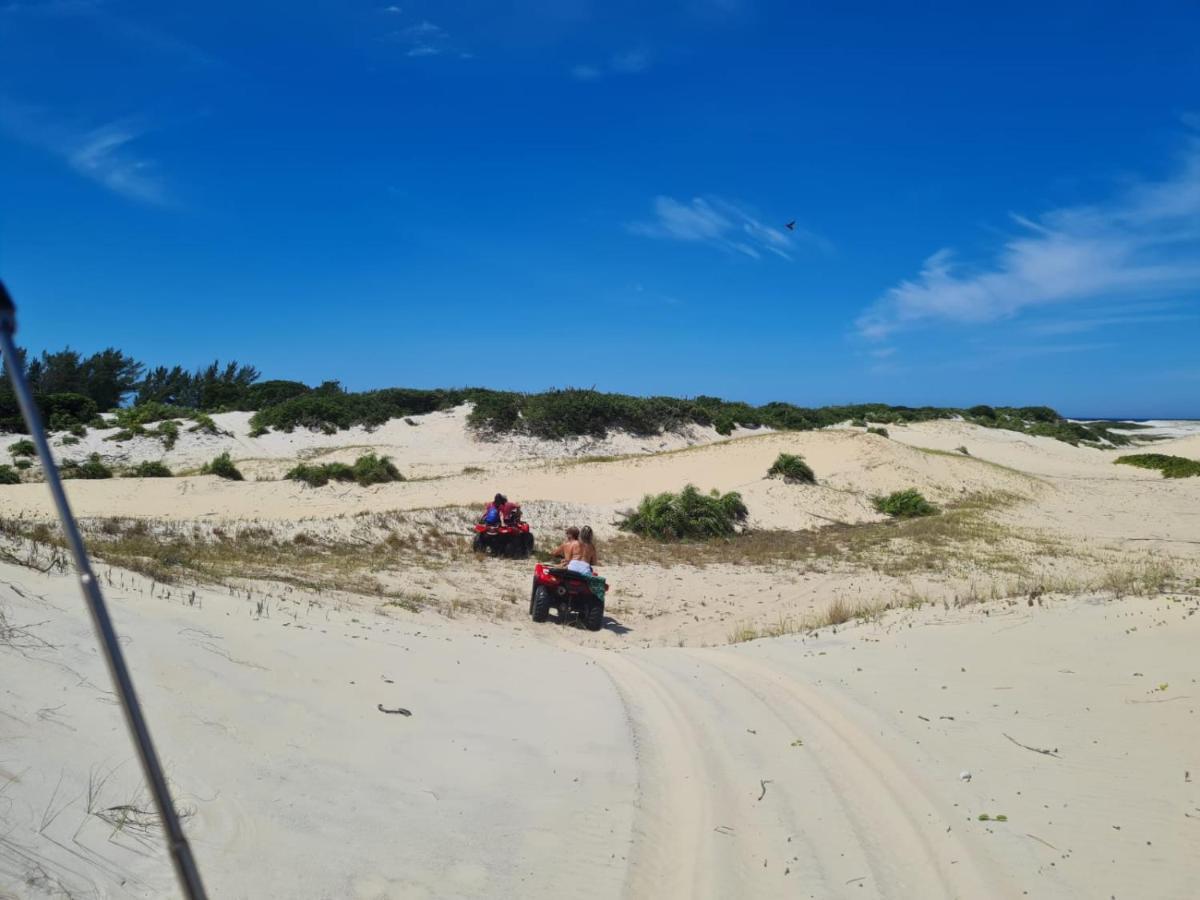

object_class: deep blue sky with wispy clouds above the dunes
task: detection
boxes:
[0,0,1200,418]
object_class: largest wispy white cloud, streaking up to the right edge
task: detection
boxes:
[857,139,1200,340]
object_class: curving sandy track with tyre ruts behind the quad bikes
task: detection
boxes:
[585,649,1010,898]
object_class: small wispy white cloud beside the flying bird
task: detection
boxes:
[628,197,824,259]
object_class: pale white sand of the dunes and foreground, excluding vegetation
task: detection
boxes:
[0,414,1200,900]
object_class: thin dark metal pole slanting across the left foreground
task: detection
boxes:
[0,282,208,900]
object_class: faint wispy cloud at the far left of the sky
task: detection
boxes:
[0,97,170,206]
